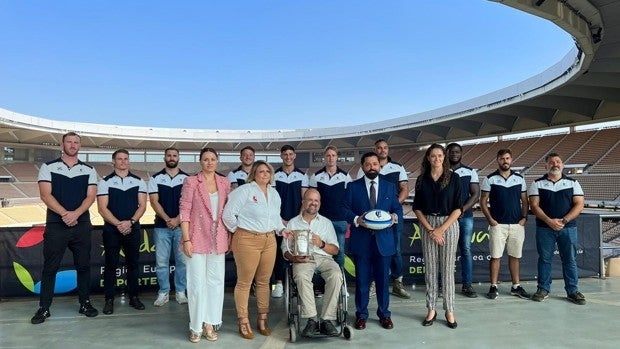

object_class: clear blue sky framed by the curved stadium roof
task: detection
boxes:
[0,0,574,129]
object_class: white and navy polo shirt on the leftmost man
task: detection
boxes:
[38,158,97,223]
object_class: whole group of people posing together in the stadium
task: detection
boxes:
[31,132,585,342]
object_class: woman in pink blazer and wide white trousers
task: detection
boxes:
[179,148,230,343]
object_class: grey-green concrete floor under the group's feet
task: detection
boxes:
[0,278,620,349]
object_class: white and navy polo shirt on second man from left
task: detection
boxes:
[97,172,146,231]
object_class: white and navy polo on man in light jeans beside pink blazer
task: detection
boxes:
[149,169,188,228]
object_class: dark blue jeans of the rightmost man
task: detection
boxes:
[536,227,579,294]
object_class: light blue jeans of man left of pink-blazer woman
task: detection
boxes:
[153,227,187,293]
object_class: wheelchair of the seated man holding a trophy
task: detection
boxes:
[284,263,353,343]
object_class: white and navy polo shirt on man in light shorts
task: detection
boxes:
[480,170,527,224]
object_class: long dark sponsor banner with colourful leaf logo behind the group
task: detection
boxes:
[0,214,601,297]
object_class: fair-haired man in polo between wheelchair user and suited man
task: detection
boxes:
[308,145,351,268]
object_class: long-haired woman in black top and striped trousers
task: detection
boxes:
[413,144,463,328]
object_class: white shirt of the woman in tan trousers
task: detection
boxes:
[222,182,284,233]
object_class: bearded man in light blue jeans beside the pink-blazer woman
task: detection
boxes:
[149,148,187,307]
